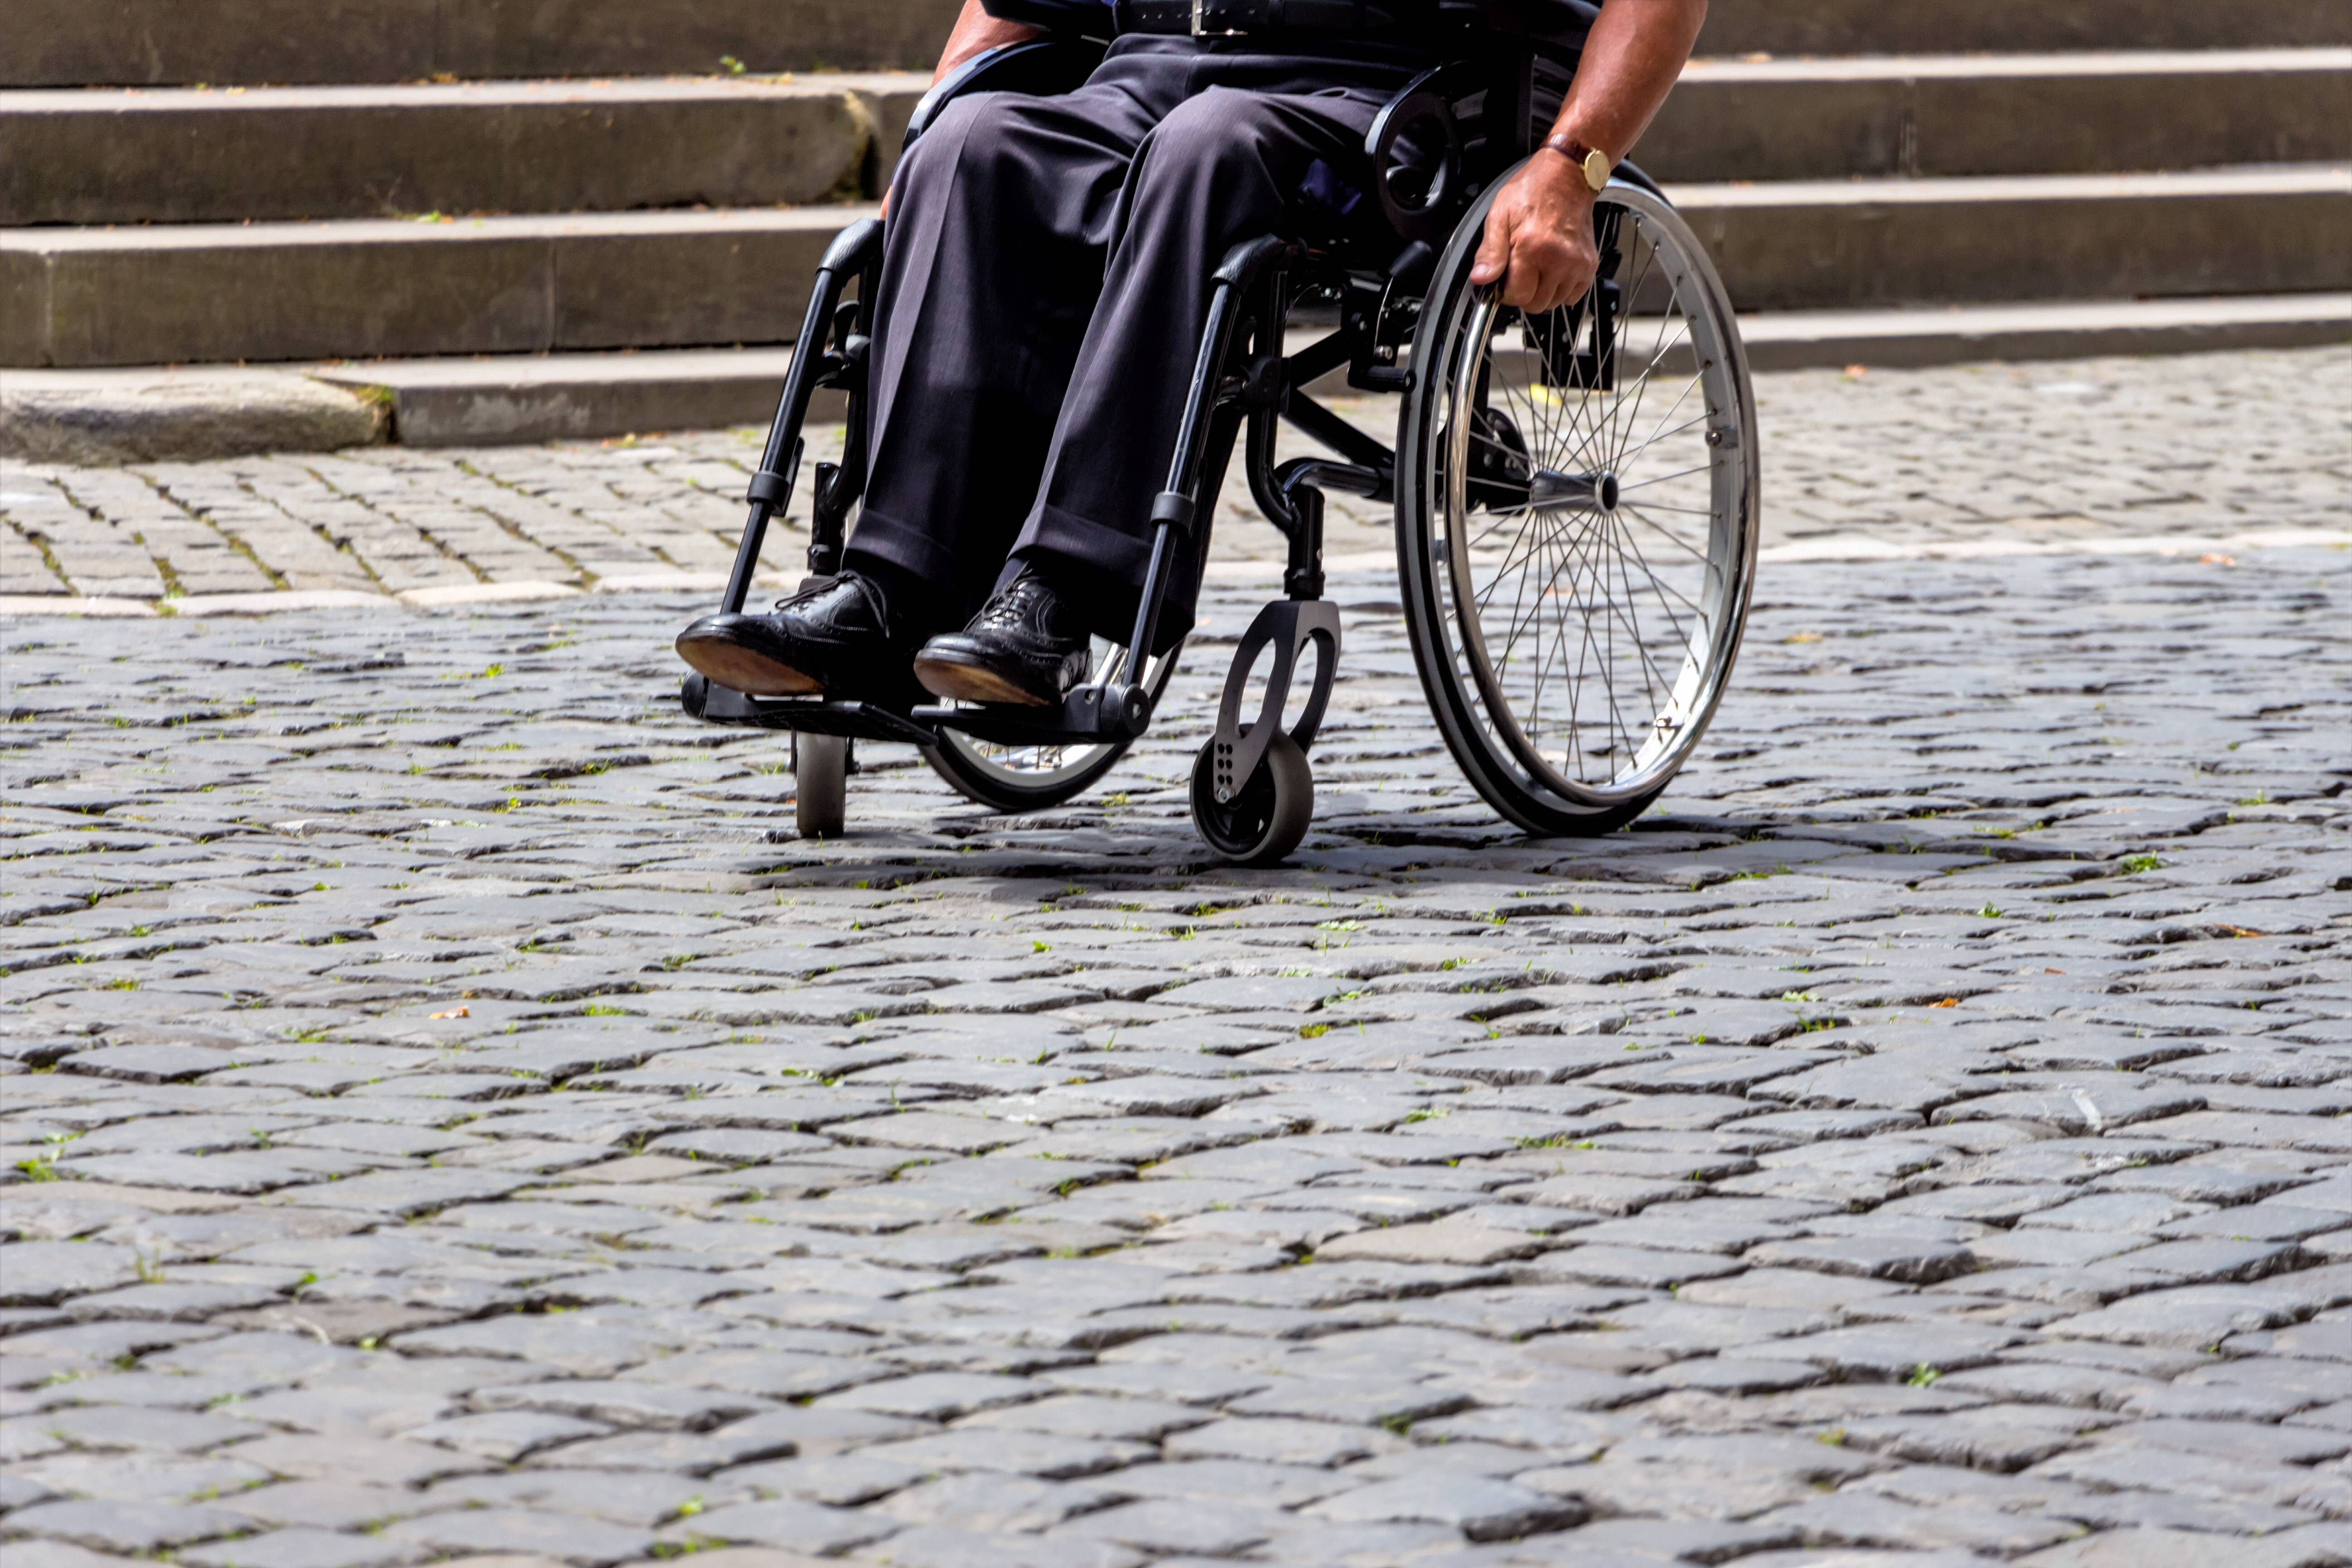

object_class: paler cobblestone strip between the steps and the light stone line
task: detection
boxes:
[0,348,2352,613]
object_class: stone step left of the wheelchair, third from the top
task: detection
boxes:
[0,207,872,364]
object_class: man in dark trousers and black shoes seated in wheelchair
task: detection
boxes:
[677,0,1705,710]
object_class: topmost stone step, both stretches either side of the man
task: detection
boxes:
[18,0,2352,87]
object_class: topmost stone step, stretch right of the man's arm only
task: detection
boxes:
[1698,0,2352,54]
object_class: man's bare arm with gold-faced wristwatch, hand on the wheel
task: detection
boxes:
[1477,0,1708,310]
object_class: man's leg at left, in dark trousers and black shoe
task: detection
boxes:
[677,87,1174,703]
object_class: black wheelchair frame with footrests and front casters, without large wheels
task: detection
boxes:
[682,0,1745,863]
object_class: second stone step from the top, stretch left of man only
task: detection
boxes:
[0,73,926,225]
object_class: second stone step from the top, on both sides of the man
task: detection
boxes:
[0,49,2352,225]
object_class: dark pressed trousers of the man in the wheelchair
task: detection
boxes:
[847,35,1428,642]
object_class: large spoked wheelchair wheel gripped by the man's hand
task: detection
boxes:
[1416,186,1754,811]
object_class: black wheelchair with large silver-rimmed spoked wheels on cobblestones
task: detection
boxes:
[682,0,1759,865]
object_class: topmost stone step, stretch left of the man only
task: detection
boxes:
[0,0,962,87]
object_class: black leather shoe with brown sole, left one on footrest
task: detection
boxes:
[677,571,920,701]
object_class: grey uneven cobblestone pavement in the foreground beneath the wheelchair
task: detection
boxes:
[0,526,2352,1568]
